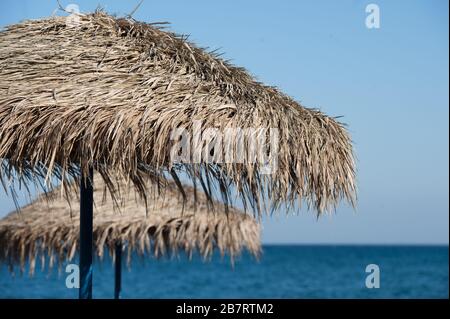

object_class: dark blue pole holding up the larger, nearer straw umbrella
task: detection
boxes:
[79,168,94,299]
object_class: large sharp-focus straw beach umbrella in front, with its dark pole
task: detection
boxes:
[0,12,356,297]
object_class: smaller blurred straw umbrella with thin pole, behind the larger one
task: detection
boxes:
[0,176,261,298]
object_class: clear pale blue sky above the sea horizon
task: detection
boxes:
[0,0,449,244]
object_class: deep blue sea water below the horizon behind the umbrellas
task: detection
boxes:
[0,246,449,298]
